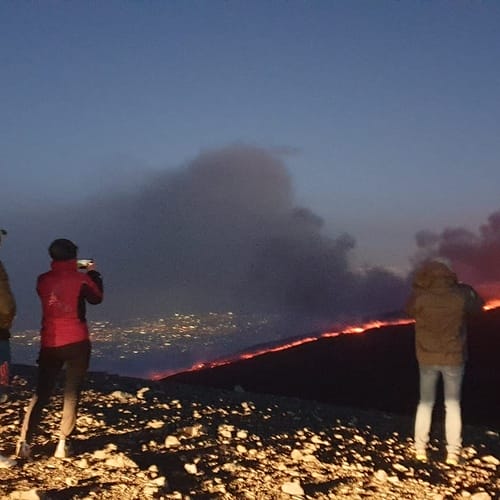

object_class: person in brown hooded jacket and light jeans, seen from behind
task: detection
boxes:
[406,260,484,465]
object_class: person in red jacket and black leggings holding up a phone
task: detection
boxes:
[16,238,103,458]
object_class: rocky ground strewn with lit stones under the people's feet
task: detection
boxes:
[0,366,500,500]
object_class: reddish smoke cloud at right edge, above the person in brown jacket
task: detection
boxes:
[414,211,500,286]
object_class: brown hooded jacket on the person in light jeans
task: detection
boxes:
[406,261,484,366]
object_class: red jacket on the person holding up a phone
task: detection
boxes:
[36,260,103,348]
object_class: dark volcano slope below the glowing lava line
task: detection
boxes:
[168,309,500,428]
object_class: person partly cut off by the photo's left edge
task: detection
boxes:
[0,229,16,468]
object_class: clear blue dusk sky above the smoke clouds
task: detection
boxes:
[0,0,500,326]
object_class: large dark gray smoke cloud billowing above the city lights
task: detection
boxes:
[2,146,406,328]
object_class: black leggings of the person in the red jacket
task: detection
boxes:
[20,340,91,443]
